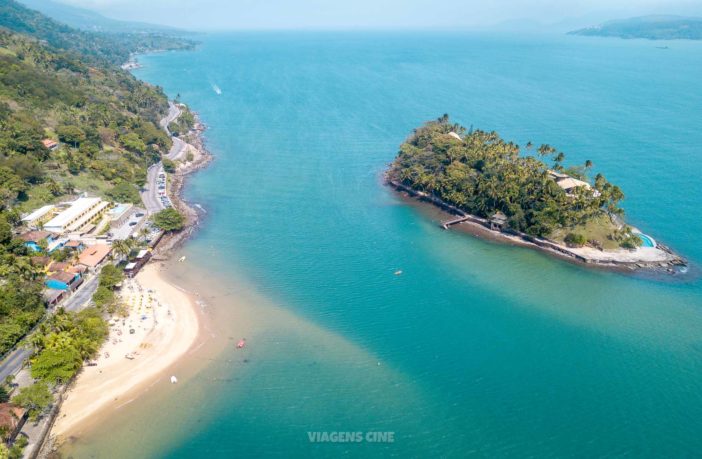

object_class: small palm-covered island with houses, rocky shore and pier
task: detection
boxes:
[386,115,685,272]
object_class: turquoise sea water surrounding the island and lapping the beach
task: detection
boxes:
[77,32,702,458]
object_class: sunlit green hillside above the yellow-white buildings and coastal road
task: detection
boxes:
[0,28,170,203]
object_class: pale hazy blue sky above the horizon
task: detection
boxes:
[59,0,702,29]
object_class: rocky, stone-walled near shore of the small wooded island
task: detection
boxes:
[384,176,687,274]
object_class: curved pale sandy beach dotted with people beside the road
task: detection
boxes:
[52,264,200,438]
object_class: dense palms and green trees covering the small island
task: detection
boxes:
[388,115,638,250]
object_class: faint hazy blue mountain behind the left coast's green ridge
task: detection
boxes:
[20,0,183,34]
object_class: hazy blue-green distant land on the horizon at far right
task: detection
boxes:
[568,16,702,40]
